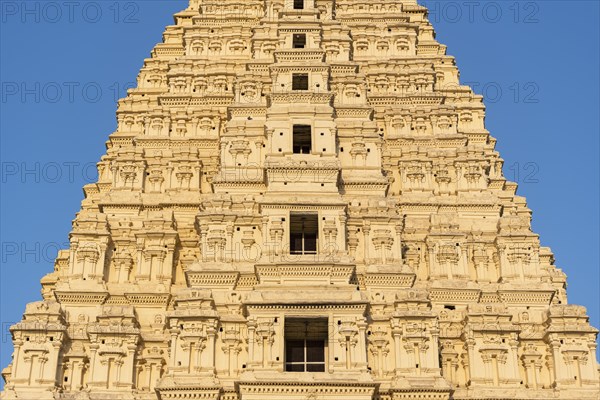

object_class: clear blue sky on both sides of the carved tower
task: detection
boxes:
[0,0,600,383]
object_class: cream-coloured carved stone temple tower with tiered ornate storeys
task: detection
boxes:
[1,0,600,400]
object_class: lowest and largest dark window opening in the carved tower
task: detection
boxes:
[285,318,327,372]
